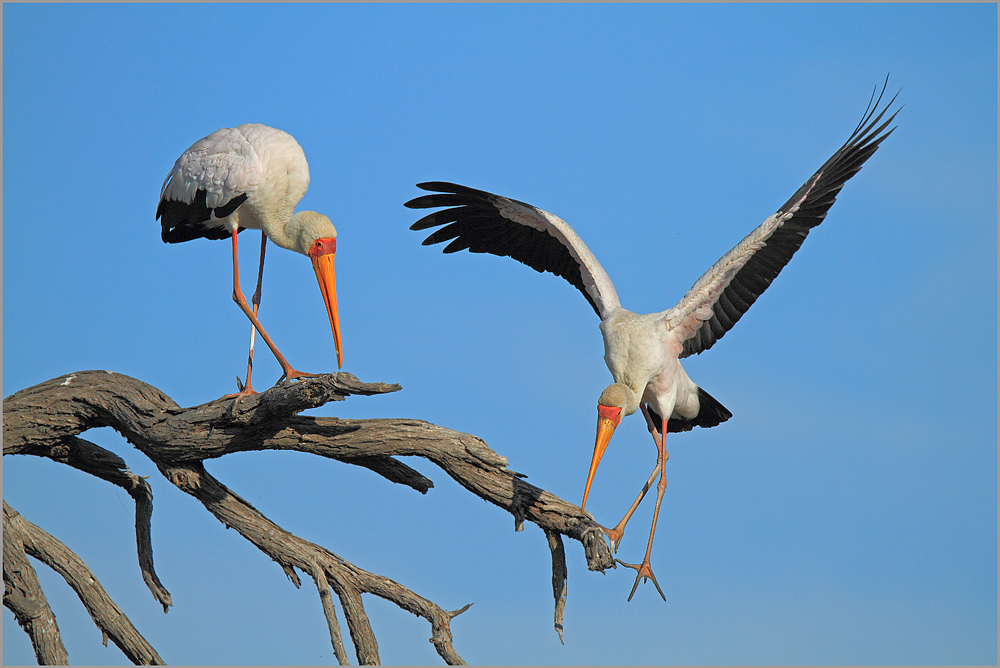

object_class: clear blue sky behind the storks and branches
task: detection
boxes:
[3,4,997,664]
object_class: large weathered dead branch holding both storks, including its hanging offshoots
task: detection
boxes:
[4,371,614,664]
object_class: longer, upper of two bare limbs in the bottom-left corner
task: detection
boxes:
[3,501,163,666]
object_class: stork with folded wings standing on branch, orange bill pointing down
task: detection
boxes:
[156,123,343,401]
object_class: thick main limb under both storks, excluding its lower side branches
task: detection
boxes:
[3,371,614,571]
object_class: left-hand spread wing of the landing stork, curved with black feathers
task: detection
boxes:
[405,181,619,318]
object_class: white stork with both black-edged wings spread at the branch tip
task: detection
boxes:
[406,86,898,600]
